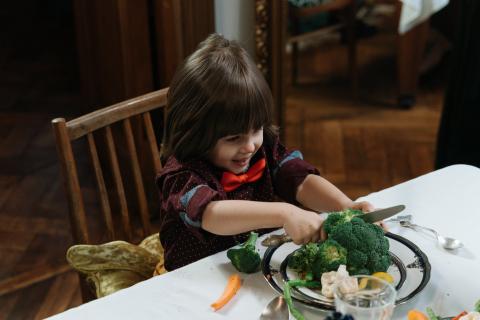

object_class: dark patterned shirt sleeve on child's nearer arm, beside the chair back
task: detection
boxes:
[161,171,222,238]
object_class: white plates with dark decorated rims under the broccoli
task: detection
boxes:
[262,232,431,310]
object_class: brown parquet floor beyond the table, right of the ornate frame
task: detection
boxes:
[286,33,447,198]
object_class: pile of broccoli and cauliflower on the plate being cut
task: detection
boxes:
[284,209,393,319]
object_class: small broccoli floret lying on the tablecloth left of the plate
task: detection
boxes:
[227,232,261,273]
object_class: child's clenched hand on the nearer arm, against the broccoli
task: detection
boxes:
[283,205,326,244]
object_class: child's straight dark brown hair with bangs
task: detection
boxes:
[162,34,277,162]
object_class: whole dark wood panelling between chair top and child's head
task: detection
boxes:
[74,0,215,108]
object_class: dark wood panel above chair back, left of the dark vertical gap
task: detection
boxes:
[74,0,154,107]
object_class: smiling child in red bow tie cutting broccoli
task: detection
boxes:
[157,34,372,270]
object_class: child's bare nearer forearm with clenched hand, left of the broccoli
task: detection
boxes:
[202,200,323,244]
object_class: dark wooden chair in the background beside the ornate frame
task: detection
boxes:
[287,0,357,97]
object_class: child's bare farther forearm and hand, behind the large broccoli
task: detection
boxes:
[296,174,374,212]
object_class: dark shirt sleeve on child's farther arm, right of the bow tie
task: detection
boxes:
[272,139,320,204]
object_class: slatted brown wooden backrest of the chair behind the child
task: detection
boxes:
[52,89,168,244]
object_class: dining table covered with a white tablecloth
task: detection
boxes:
[51,164,480,320]
